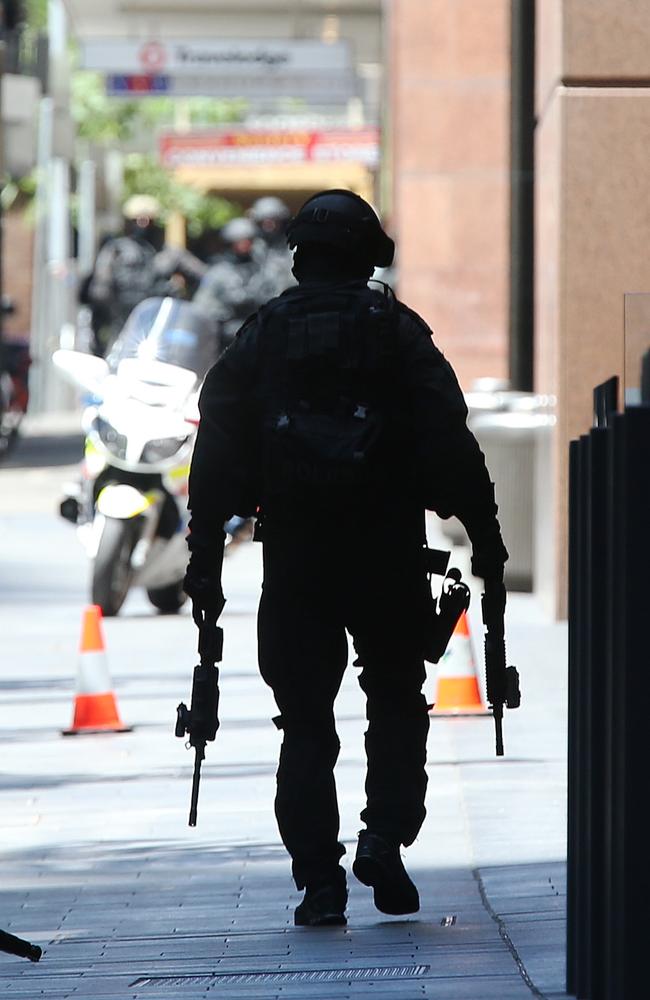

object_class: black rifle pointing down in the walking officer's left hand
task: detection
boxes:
[175,605,223,826]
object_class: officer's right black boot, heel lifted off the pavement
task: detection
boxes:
[352,830,420,916]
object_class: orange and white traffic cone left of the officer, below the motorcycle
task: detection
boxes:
[63,604,131,736]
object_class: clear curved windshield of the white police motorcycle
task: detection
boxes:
[106,298,217,378]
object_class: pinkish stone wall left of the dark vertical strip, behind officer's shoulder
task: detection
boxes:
[386,0,510,389]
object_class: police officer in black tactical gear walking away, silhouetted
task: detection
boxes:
[185,190,508,926]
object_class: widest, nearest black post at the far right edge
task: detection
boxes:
[606,406,650,1000]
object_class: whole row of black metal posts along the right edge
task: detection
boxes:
[566,362,650,1000]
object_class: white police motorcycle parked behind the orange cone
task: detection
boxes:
[53,298,217,615]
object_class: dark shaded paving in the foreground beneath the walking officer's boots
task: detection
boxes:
[0,840,565,1000]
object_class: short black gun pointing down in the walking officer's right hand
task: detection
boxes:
[481,578,521,757]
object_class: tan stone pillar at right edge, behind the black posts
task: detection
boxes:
[535,0,650,615]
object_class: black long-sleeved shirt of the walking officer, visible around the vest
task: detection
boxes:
[189,283,499,551]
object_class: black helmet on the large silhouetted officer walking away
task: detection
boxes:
[287,188,395,267]
